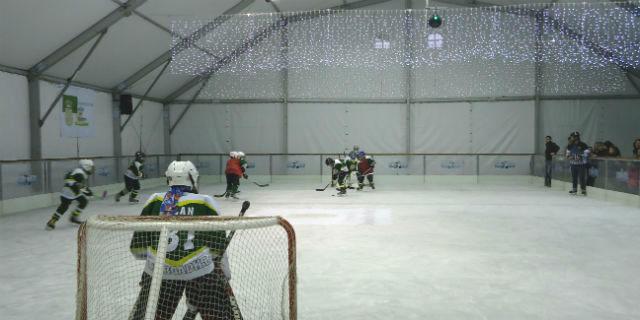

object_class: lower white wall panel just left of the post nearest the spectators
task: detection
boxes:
[471,101,535,153]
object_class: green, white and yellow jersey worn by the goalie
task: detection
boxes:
[130,192,226,280]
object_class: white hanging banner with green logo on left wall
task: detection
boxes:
[60,87,96,138]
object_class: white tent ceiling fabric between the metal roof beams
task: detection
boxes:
[0,0,636,103]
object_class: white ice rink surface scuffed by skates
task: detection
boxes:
[0,181,640,320]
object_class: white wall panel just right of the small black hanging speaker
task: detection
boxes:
[120,99,164,155]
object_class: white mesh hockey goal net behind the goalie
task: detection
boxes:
[76,216,296,320]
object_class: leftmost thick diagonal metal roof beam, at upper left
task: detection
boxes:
[29,0,147,76]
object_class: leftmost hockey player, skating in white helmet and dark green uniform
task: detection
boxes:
[47,159,94,230]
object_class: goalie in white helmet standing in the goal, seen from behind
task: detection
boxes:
[129,161,231,320]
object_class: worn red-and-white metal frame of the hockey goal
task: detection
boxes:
[76,215,297,320]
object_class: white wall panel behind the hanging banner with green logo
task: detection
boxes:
[40,81,113,158]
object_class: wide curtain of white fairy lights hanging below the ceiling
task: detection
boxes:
[170,1,640,98]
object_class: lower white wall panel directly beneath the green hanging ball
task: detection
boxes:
[411,102,471,153]
